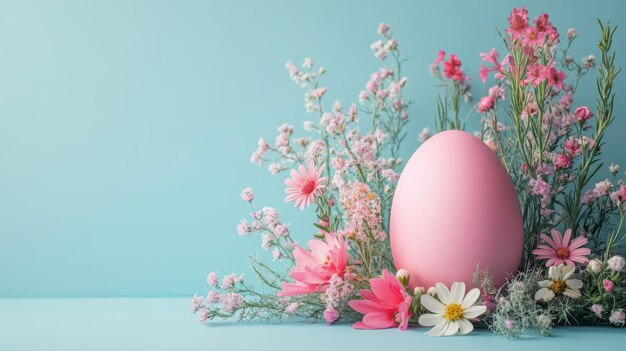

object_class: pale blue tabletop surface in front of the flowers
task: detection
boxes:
[0,298,626,351]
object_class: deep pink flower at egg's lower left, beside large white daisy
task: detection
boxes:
[349,269,412,330]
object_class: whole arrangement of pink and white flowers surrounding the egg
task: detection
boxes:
[191,7,626,338]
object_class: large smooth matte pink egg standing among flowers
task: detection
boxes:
[390,130,524,288]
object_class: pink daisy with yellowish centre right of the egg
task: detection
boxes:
[533,229,591,267]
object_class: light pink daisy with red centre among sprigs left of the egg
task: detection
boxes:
[285,160,327,209]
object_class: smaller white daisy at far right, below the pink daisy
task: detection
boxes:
[535,264,583,302]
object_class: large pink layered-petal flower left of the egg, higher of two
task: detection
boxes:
[277,233,348,297]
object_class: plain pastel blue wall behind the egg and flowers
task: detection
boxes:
[0,0,626,296]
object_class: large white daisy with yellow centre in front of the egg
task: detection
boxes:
[419,283,487,336]
